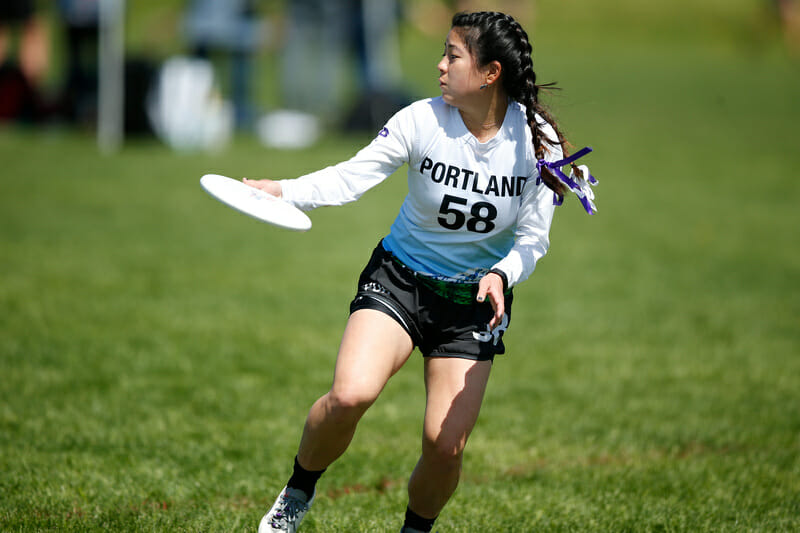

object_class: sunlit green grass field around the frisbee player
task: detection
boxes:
[0,0,800,533]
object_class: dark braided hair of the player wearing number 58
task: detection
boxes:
[452,11,567,195]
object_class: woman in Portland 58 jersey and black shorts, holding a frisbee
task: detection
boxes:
[250,12,590,533]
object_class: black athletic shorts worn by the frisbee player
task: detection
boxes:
[350,243,514,361]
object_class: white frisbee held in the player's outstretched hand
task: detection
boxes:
[200,174,311,231]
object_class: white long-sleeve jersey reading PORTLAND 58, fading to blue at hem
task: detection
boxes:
[281,97,563,286]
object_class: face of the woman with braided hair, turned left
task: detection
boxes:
[437,29,485,107]
